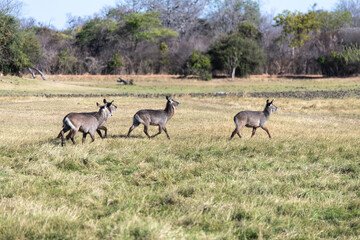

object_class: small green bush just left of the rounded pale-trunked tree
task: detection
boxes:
[187,50,211,81]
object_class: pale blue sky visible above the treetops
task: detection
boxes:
[21,0,338,30]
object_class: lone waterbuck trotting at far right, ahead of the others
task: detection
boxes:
[230,99,277,139]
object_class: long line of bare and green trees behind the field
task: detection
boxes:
[0,0,360,80]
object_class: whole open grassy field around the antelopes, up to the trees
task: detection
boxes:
[0,76,360,239]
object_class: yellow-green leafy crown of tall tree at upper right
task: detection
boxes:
[274,10,321,48]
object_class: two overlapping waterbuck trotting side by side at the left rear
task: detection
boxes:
[58,99,117,146]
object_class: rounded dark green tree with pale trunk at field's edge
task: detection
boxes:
[209,24,265,77]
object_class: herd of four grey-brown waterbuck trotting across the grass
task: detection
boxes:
[58,96,277,146]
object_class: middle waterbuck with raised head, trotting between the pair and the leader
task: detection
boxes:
[127,96,180,139]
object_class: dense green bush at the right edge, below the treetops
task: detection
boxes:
[317,45,360,77]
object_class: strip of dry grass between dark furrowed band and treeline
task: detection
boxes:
[4,75,360,95]
